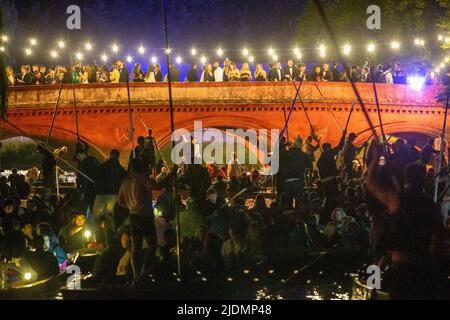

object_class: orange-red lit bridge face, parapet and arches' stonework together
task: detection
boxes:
[0,82,450,159]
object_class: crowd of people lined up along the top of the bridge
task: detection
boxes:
[6,59,450,86]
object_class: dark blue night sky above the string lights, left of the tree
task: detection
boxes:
[5,0,306,64]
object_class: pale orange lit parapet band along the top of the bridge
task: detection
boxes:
[8,82,443,110]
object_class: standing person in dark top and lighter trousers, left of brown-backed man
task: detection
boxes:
[93,149,127,242]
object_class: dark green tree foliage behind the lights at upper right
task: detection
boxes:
[298,0,448,64]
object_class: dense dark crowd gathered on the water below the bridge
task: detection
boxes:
[0,130,450,299]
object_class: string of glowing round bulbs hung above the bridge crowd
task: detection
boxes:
[0,34,450,73]
